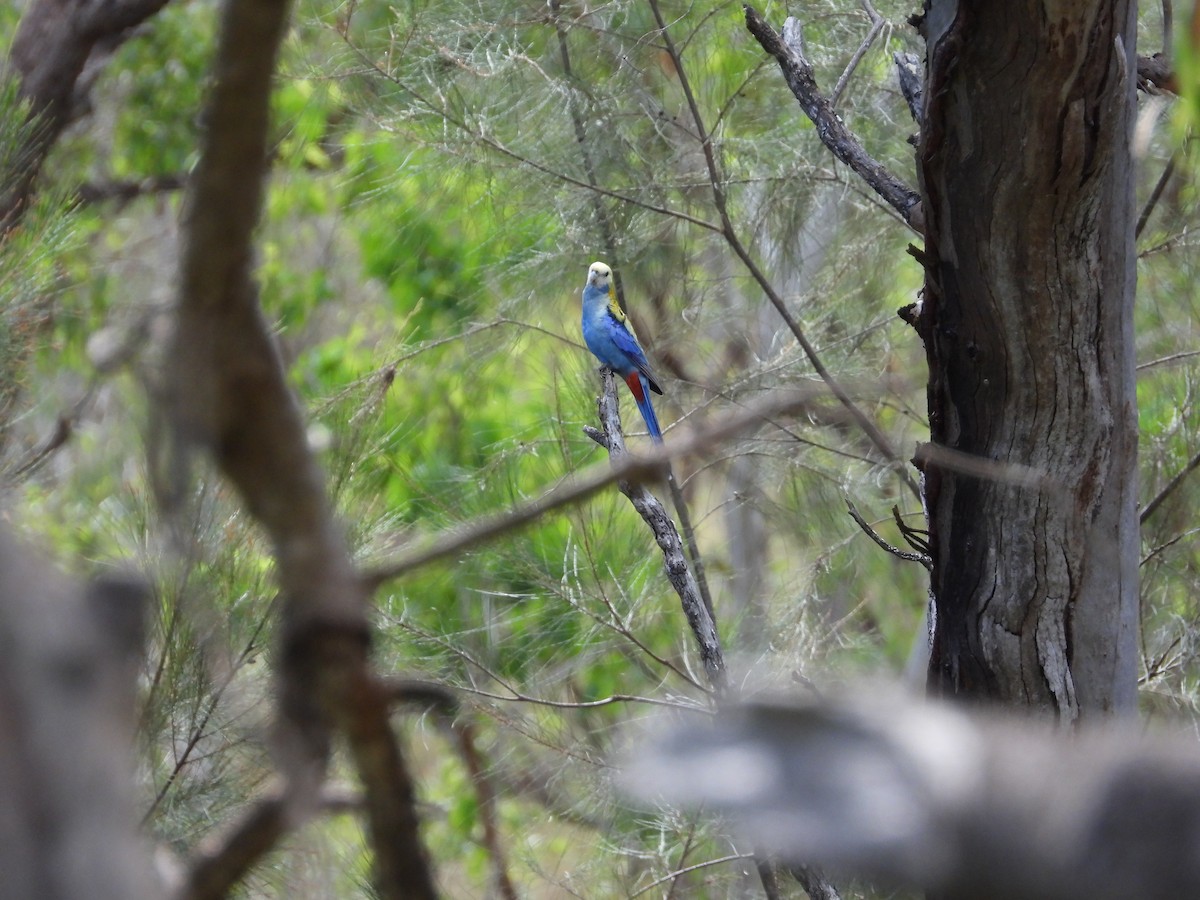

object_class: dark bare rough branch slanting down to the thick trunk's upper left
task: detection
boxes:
[745,5,925,234]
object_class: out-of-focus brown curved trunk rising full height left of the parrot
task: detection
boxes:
[163,0,434,898]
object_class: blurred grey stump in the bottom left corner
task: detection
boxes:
[0,529,164,900]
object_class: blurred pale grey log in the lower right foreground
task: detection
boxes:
[626,691,1200,900]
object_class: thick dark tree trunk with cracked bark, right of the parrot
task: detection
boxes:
[914,0,1139,720]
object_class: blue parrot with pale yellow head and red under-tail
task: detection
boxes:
[583,263,662,444]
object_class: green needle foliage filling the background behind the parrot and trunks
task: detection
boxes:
[0,0,1200,898]
